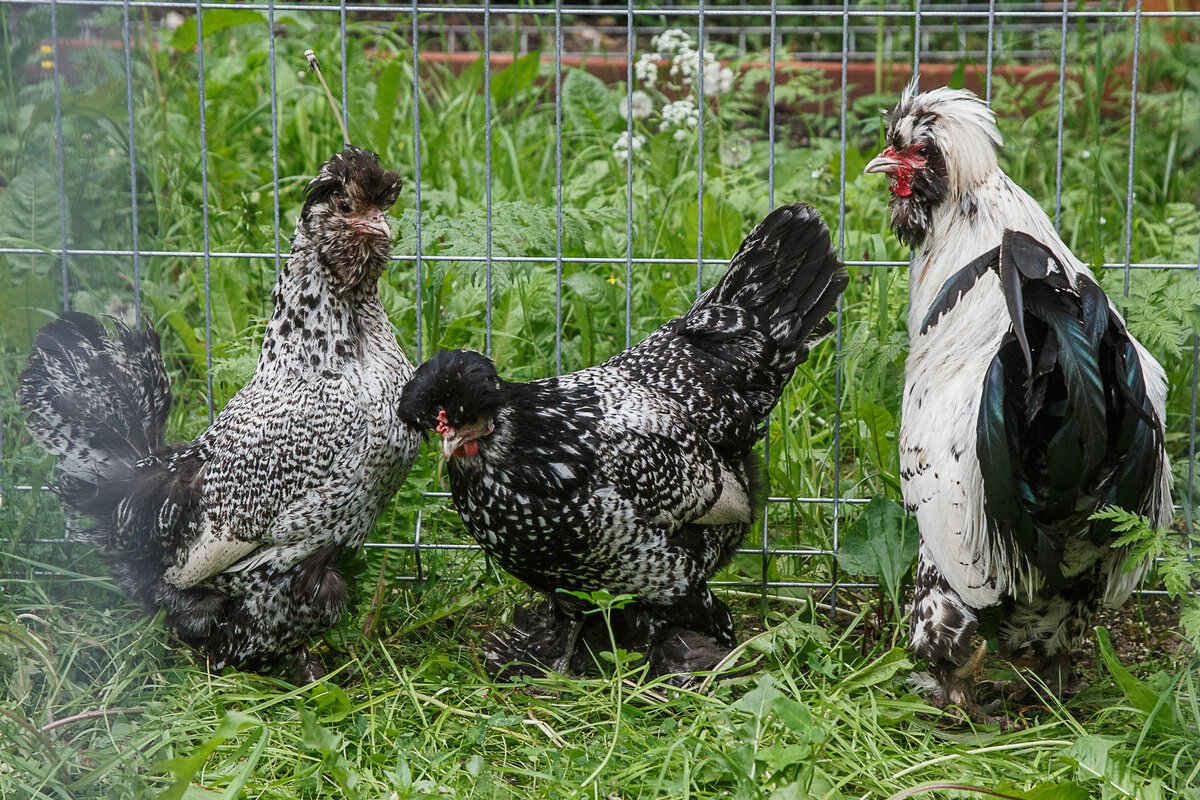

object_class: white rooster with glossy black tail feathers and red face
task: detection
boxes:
[866,80,1171,717]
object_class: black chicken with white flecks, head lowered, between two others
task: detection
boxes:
[401,204,847,676]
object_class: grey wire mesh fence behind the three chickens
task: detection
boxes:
[0,0,1200,599]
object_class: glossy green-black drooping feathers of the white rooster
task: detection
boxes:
[977,230,1162,585]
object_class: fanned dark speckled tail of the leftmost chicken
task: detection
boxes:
[18,313,170,543]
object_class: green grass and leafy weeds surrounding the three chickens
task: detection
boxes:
[0,6,1200,800]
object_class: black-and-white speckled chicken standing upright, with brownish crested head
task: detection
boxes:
[19,146,420,682]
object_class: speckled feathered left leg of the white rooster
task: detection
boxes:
[911,542,986,720]
